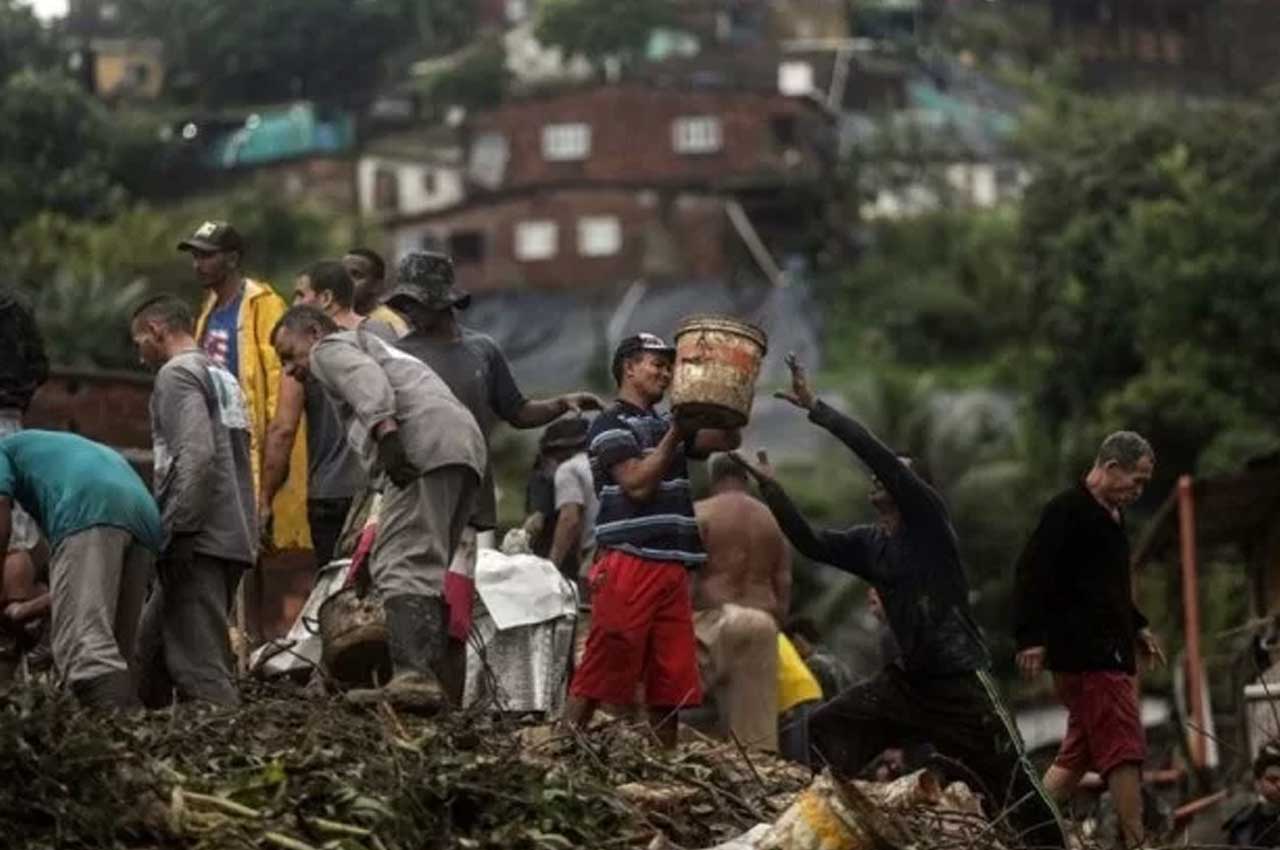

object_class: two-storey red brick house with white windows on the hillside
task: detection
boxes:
[384,83,829,292]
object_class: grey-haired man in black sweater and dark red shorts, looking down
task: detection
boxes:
[1015,431,1164,847]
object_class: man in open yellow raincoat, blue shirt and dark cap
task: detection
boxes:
[178,221,311,549]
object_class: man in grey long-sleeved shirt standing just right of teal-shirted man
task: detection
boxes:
[131,296,257,707]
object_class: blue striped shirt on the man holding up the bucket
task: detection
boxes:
[588,401,707,567]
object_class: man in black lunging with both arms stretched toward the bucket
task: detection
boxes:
[735,356,1066,847]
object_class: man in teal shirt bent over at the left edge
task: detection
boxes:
[0,430,164,709]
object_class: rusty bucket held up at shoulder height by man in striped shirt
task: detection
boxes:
[671,316,769,428]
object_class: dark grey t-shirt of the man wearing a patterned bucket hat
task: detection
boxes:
[396,328,525,529]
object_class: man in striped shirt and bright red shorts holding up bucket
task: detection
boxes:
[564,334,741,748]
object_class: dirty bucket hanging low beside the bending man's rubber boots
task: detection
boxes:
[316,586,392,685]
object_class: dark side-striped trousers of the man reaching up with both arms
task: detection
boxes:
[809,666,1066,847]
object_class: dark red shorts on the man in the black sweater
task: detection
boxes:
[1053,671,1147,776]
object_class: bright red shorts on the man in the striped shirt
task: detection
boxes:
[570,549,703,708]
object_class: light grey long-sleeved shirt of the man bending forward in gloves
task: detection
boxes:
[311,330,489,477]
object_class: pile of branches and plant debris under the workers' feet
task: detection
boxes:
[0,685,1029,850]
